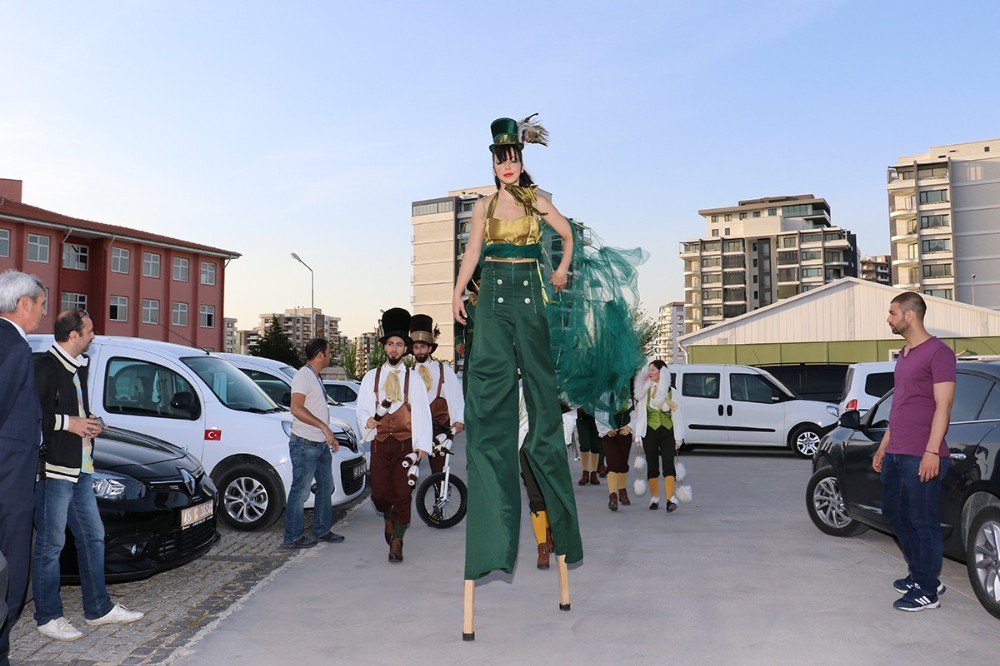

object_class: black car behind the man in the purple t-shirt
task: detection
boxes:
[806,363,1000,618]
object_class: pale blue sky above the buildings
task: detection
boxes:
[0,0,1000,336]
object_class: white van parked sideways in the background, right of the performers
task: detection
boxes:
[668,363,837,458]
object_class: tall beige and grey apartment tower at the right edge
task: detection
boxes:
[886,139,1000,309]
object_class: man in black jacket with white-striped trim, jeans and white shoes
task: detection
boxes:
[31,310,143,641]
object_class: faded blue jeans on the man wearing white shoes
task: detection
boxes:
[31,474,114,626]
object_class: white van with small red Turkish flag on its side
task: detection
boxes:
[28,335,367,530]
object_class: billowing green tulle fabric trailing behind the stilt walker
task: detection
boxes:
[540,221,649,414]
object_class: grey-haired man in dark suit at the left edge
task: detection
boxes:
[0,271,45,666]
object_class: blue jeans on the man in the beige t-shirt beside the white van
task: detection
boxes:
[284,435,333,543]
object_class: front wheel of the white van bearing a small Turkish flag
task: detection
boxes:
[217,465,285,532]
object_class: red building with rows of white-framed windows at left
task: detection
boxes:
[0,179,240,351]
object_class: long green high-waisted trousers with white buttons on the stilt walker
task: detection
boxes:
[465,261,583,580]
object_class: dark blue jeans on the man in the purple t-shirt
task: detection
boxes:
[882,453,948,593]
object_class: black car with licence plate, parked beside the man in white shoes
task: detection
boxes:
[60,428,219,583]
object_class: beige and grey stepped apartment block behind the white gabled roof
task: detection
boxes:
[679,194,858,332]
